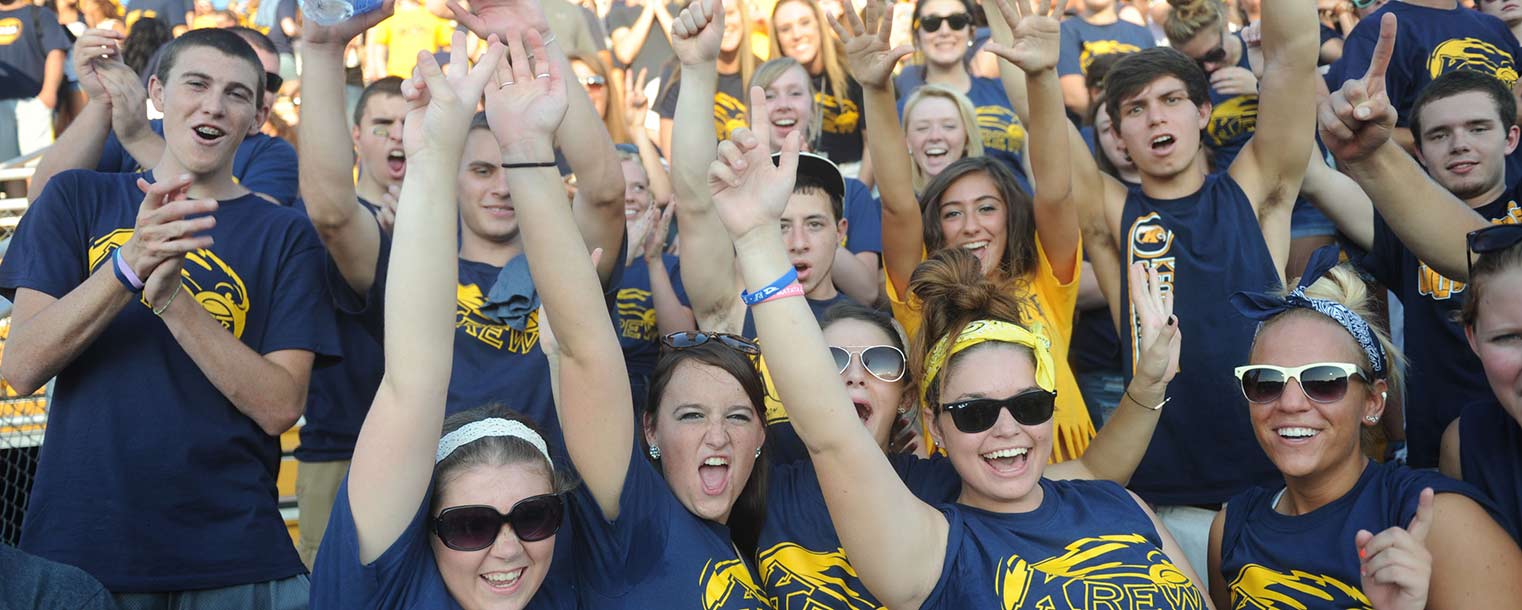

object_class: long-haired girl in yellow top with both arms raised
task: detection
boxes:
[836,0,1094,461]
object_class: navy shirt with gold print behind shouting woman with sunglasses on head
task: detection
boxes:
[613,254,686,412]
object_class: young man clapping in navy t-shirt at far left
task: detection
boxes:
[0,29,338,610]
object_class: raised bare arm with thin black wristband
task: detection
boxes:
[486,27,635,520]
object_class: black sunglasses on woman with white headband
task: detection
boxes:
[434,493,565,551]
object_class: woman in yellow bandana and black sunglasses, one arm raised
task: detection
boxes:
[709,50,1207,608]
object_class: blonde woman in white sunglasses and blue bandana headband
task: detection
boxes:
[1210,246,1522,608]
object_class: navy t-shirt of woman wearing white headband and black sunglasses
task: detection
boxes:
[310,476,575,610]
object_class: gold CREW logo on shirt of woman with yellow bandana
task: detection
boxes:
[994,534,1205,610]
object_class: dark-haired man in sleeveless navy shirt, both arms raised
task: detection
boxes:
[991,0,1317,566]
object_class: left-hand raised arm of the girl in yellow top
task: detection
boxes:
[828,0,925,295]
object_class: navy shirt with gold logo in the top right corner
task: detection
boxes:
[1326,2,1522,126]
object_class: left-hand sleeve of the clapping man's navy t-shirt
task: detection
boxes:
[0,172,90,301]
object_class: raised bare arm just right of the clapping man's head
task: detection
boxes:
[297,0,392,295]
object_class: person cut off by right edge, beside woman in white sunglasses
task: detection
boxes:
[1441,225,1522,540]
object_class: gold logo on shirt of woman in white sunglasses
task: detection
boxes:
[1227,563,1371,610]
